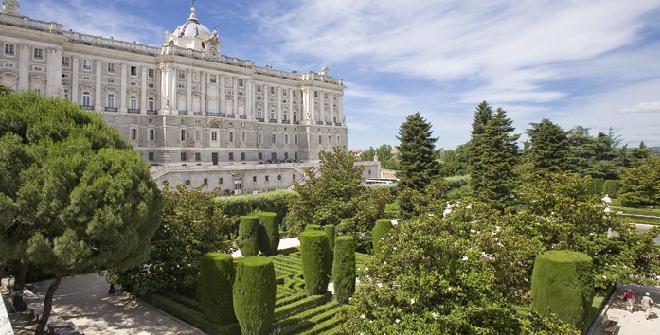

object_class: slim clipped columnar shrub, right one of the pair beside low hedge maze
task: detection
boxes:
[332,236,356,304]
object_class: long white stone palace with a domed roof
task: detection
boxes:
[0,0,380,193]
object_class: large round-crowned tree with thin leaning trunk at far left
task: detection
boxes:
[0,93,160,334]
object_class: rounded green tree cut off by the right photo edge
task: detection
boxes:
[619,157,660,206]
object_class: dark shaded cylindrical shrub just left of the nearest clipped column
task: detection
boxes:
[199,253,236,325]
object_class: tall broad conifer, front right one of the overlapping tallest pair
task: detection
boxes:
[472,108,520,209]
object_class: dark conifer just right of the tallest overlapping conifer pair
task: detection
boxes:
[527,119,569,172]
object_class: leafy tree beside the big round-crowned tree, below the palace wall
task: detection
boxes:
[118,186,232,295]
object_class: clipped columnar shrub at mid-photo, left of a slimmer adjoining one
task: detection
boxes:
[299,231,332,295]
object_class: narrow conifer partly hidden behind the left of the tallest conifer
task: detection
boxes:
[468,100,493,194]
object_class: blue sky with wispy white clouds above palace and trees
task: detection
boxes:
[21,0,660,148]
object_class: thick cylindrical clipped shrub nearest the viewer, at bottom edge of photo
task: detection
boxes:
[233,256,277,335]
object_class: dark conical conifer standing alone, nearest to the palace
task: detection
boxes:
[397,113,439,191]
